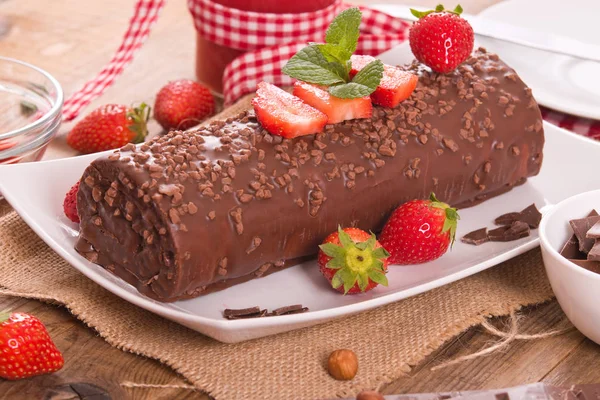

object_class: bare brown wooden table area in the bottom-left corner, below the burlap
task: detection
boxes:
[0,296,209,400]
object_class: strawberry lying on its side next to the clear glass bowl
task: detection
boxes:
[67,103,150,154]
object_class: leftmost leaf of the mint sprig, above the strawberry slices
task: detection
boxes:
[283,45,345,86]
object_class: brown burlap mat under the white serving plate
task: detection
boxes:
[0,97,552,399]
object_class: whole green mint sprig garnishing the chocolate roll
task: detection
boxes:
[283,8,383,99]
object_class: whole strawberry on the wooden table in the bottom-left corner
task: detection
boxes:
[0,313,65,380]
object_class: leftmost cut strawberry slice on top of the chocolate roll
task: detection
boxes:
[252,82,327,139]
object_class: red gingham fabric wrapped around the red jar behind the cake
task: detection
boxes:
[188,0,410,104]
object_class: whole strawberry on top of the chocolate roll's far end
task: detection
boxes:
[408,4,475,74]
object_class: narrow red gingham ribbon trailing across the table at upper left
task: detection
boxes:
[63,0,165,121]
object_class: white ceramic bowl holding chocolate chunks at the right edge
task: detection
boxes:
[539,190,600,344]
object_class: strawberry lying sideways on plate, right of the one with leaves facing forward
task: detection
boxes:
[379,193,460,265]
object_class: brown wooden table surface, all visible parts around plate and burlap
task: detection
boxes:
[0,0,600,399]
